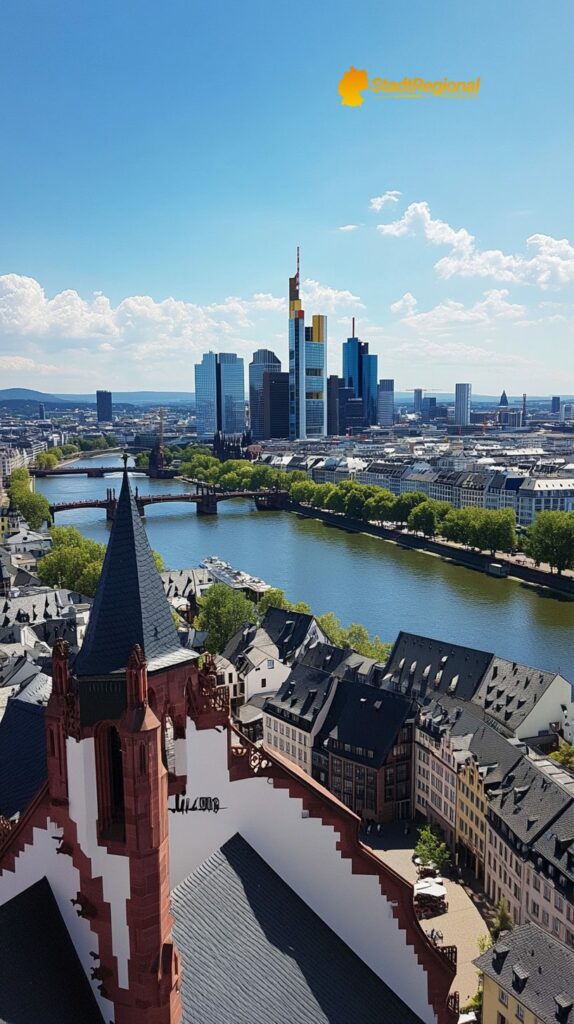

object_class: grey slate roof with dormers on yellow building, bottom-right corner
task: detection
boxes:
[475,922,574,1024]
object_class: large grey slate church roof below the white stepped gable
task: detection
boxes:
[172,835,421,1024]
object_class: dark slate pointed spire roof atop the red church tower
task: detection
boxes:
[74,470,192,677]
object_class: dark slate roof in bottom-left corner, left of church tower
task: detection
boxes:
[0,879,103,1024]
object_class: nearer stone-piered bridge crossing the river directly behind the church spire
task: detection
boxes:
[50,484,289,522]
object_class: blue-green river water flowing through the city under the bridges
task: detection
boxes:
[36,455,574,681]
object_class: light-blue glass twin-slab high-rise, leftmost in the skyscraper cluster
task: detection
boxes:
[195,352,246,437]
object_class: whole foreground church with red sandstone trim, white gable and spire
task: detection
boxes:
[0,471,457,1024]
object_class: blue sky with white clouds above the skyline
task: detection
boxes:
[0,0,574,393]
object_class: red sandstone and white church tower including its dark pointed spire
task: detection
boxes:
[46,471,197,1024]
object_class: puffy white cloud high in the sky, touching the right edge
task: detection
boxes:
[377,203,574,289]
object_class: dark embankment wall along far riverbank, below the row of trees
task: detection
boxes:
[289,502,574,599]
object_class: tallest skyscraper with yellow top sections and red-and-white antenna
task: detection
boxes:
[289,248,326,440]
